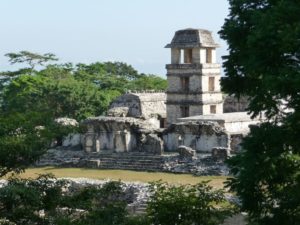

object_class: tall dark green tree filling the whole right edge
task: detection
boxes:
[220,0,300,225]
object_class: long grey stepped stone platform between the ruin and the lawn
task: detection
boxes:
[35,149,228,176]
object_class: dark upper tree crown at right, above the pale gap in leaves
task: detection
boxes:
[220,0,300,118]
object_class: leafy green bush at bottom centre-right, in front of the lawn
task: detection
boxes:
[147,182,234,225]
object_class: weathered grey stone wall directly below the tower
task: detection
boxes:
[163,122,230,152]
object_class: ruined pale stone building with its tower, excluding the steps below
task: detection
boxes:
[83,29,259,153]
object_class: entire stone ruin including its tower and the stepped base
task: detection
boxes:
[40,29,260,175]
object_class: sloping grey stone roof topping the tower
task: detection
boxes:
[165,28,219,48]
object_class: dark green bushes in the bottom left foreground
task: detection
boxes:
[0,178,136,225]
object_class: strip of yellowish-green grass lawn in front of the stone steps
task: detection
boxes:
[10,167,227,188]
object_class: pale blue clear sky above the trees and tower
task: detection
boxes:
[0,0,229,76]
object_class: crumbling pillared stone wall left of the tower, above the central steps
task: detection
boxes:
[82,117,163,154]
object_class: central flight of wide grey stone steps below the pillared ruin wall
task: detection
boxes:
[87,152,164,171]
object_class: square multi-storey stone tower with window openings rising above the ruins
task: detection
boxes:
[166,29,223,124]
